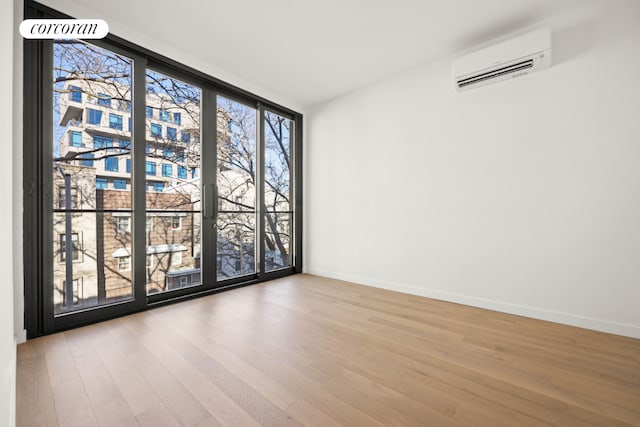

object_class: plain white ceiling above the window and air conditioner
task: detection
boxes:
[42,0,585,108]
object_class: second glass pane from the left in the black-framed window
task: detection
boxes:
[145,70,201,294]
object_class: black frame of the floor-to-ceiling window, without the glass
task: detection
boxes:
[23,0,303,339]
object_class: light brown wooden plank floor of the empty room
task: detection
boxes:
[17,275,640,427]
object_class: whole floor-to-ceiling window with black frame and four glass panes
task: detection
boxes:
[24,3,302,337]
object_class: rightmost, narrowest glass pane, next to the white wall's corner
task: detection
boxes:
[264,111,292,271]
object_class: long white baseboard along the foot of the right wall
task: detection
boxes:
[305,269,640,339]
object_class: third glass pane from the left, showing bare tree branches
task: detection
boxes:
[216,96,256,280]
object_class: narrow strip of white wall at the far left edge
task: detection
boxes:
[0,1,17,426]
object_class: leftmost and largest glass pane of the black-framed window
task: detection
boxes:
[51,40,133,314]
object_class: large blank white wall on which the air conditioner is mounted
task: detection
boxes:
[305,1,640,338]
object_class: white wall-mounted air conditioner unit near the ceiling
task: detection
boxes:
[453,28,551,91]
